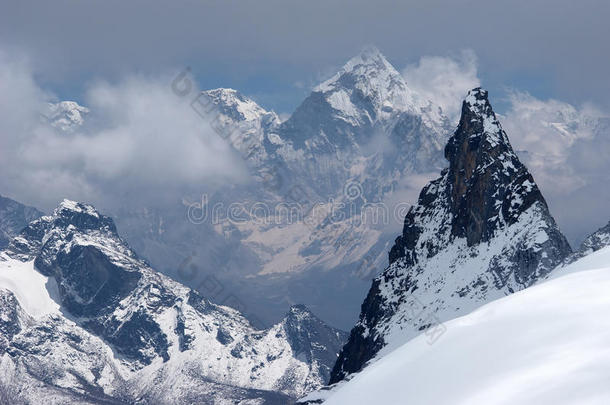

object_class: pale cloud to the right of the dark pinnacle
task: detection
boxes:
[501,91,610,242]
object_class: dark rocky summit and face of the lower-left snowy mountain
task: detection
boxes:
[10,201,171,364]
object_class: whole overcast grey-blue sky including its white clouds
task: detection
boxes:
[0,0,610,241]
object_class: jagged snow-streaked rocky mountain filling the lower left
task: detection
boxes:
[0,200,346,404]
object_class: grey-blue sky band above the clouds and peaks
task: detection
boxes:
[0,0,610,113]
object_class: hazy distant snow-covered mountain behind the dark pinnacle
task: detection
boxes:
[96,48,451,328]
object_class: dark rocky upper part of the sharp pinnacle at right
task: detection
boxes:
[436,88,548,246]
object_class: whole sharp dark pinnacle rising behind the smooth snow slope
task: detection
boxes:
[330,88,571,383]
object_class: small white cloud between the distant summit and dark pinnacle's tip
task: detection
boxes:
[402,50,481,122]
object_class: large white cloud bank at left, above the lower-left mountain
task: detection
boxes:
[0,49,244,208]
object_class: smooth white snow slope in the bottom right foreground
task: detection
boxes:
[310,247,610,405]
